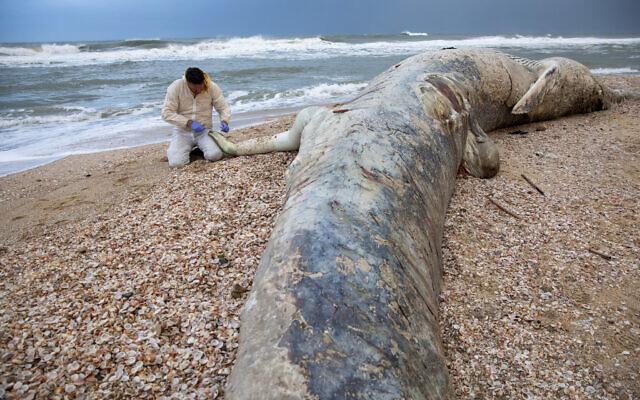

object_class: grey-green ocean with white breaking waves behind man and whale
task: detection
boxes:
[0,32,640,176]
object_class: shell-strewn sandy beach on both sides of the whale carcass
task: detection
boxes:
[0,76,640,399]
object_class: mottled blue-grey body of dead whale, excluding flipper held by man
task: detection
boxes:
[226,49,612,399]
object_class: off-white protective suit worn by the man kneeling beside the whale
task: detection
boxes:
[162,73,231,167]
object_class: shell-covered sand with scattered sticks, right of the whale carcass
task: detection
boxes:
[440,78,640,399]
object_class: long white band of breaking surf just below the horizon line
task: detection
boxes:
[0,35,640,67]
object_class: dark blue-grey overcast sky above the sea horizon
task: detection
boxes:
[0,0,640,43]
